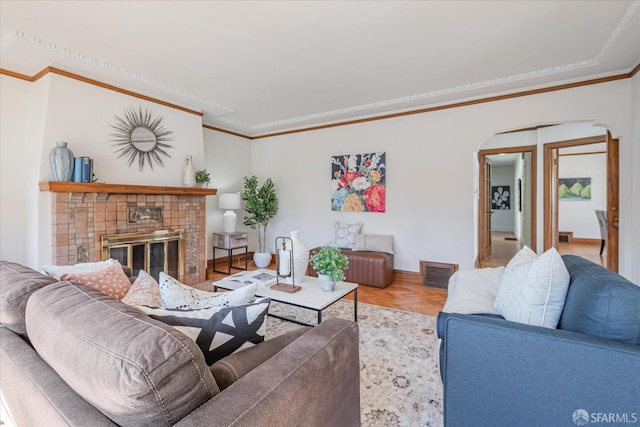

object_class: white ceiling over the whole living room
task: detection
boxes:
[0,0,640,136]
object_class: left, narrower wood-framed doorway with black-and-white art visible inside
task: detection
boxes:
[476,145,537,268]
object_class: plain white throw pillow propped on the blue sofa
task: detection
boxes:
[495,246,569,328]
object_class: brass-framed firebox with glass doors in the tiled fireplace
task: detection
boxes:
[100,230,184,282]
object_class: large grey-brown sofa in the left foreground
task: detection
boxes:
[0,261,360,427]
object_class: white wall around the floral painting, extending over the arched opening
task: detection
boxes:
[252,80,640,276]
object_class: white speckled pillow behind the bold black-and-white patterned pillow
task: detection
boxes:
[159,271,258,310]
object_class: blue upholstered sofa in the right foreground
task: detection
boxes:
[437,255,640,427]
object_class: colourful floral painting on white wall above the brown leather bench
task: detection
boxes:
[331,153,387,212]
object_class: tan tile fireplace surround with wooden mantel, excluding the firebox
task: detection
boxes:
[40,182,216,284]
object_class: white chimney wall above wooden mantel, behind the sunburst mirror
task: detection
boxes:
[40,75,204,187]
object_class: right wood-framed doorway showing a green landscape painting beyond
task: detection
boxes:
[543,132,619,271]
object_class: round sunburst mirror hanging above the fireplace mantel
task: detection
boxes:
[109,107,173,170]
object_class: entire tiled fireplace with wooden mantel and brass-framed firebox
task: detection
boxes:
[40,182,216,285]
